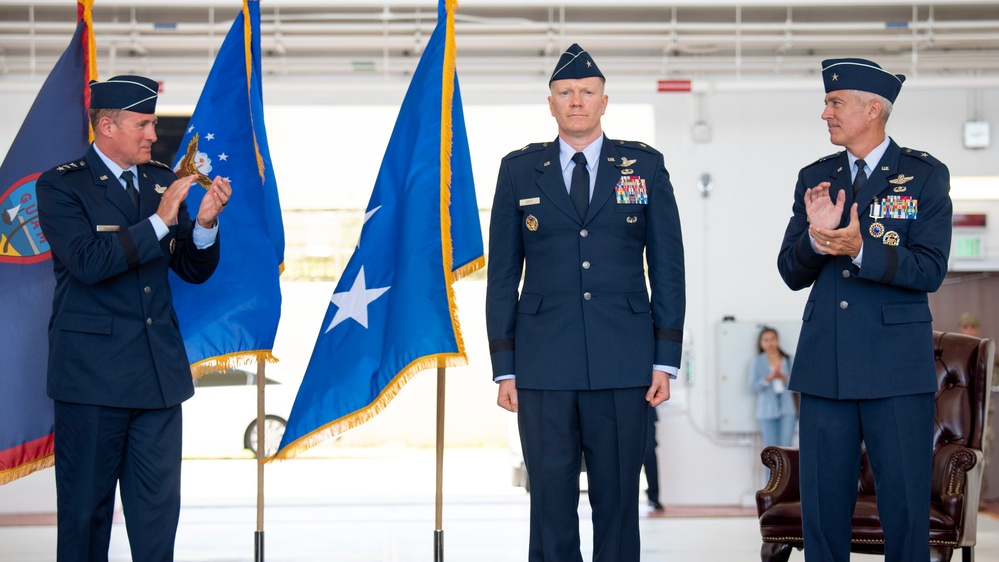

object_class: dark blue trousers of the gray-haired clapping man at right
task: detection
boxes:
[799,393,934,562]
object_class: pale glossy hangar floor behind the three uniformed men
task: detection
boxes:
[0,448,999,562]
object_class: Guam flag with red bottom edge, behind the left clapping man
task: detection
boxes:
[0,0,97,484]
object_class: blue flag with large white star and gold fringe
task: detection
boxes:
[272,0,485,460]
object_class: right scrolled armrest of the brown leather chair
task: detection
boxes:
[931,443,984,526]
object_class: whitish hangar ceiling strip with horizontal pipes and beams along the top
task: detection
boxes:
[0,0,999,83]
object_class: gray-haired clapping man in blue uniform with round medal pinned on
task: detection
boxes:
[778,59,952,562]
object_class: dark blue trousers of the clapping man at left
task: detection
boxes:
[55,401,182,562]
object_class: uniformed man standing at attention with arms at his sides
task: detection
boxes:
[486,45,685,562]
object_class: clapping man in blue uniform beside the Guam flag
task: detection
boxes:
[37,76,231,562]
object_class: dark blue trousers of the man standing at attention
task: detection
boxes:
[517,388,649,562]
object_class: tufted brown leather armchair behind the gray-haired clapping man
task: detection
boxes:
[756,332,995,562]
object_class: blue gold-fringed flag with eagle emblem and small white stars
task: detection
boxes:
[170,0,284,376]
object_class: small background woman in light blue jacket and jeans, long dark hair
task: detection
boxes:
[749,327,798,447]
